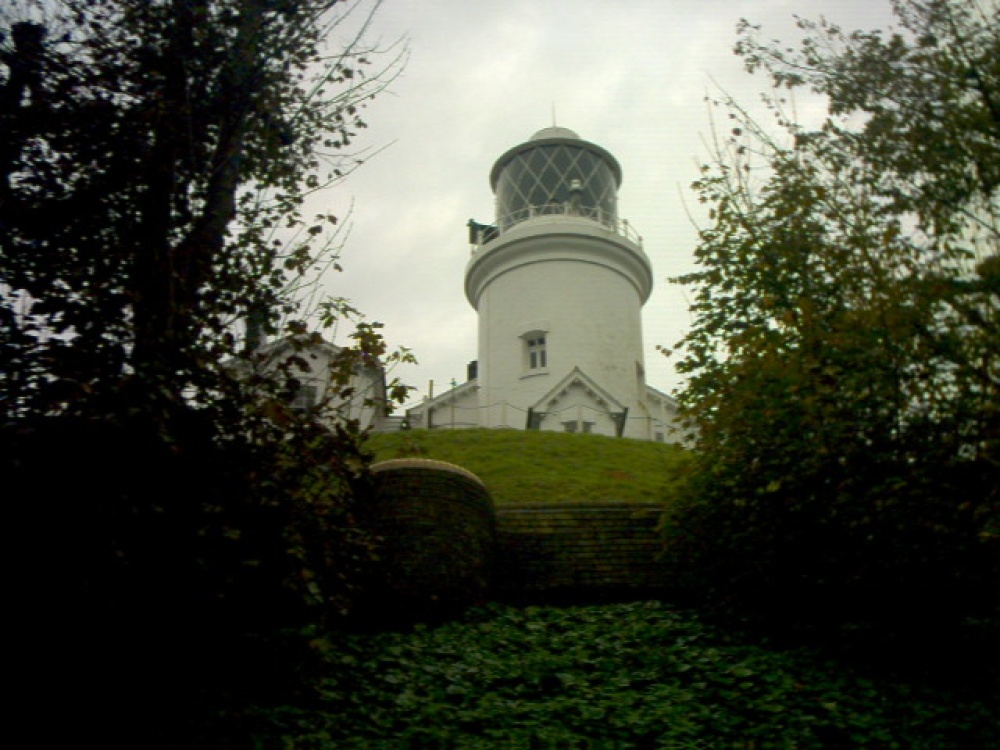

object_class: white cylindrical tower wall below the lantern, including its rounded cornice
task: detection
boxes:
[466,216,652,428]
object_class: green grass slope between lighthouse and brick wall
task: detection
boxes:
[368,429,690,504]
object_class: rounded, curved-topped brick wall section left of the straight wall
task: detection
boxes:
[366,459,496,619]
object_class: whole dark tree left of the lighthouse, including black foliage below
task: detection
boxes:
[0,0,405,746]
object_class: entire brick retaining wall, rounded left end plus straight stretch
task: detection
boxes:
[370,459,665,610]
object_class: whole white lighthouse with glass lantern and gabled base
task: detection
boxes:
[411,127,676,440]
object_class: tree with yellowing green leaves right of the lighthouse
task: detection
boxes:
[667,0,1000,648]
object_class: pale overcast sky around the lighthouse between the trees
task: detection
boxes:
[322,0,892,403]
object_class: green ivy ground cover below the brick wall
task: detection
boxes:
[269,602,1000,750]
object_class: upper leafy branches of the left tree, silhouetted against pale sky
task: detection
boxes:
[0,0,402,424]
